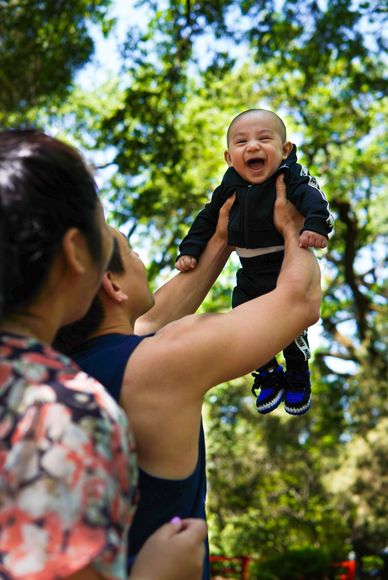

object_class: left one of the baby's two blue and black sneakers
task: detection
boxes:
[252,365,286,415]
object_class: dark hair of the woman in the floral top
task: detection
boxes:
[0,130,102,319]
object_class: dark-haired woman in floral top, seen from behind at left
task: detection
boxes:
[0,131,205,580]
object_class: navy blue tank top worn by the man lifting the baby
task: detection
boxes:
[72,334,210,580]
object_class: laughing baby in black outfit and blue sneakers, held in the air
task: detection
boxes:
[176,109,334,415]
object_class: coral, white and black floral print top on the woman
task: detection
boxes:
[0,334,137,580]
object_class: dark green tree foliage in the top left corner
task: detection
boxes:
[0,0,112,121]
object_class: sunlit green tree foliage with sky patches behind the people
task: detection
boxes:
[0,0,388,578]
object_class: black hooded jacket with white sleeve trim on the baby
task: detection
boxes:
[179,145,334,259]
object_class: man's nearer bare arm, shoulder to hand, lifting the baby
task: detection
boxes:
[122,174,320,478]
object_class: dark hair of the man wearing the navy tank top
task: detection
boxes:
[53,238,124,355]
